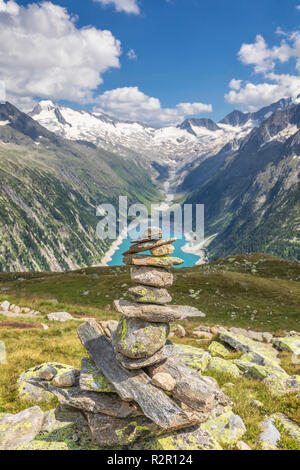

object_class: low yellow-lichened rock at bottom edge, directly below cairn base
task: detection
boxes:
[131,426,222,451]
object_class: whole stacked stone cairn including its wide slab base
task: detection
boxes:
[26,228,230,449]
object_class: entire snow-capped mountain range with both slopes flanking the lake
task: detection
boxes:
[0,98,300,270]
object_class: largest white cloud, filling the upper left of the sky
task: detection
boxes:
[0,0,121,109]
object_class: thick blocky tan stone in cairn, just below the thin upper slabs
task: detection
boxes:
[130,266,174,287]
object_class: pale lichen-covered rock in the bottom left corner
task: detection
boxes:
[0,406,44,450]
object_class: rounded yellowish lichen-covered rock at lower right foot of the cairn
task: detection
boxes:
[200,410,246,446]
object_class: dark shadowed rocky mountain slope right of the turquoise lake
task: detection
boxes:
[183,104,300,260]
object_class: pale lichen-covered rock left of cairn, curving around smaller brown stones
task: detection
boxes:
[18,362,78,403]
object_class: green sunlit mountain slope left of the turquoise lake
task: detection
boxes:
[0,103,162,271]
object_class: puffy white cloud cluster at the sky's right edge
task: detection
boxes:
[225,29,300,111]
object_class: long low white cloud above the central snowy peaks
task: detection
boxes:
[95,87,212,125]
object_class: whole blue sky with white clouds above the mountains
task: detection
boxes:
[0,0,300,125]
